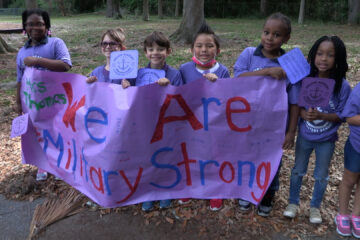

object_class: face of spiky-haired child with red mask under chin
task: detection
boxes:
[191,34,220,63]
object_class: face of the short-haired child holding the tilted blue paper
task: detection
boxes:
[261,19,290,57]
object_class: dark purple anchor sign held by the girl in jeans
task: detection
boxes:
[299,78,335,108]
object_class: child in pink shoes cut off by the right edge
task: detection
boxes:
[335,83,360,238]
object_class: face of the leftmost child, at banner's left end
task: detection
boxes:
[25,14,47,43]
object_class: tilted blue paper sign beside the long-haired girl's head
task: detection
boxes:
[278,48,310,84]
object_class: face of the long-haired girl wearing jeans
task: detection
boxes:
[314,41,335,77]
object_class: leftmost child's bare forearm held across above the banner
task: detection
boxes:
[24,57,70,72]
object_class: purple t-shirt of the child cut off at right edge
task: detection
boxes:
[341,83,360,153]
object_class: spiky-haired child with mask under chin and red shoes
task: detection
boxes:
[179,24,230,211]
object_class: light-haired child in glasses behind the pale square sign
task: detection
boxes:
[86,28,135,84]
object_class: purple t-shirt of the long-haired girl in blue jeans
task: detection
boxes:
[299,79,351,142]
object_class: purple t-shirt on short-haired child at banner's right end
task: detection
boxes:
[234,44,300,104]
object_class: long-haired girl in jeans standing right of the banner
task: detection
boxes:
[283,36,351,223]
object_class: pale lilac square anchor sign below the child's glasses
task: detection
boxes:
[109,50,139,79]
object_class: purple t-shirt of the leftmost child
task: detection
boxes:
[16,37,72,82]
